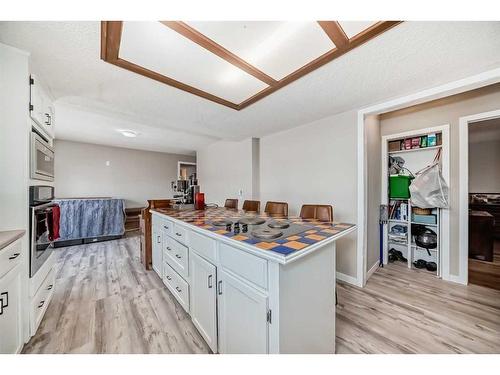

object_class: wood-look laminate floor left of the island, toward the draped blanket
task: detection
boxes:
[23,236,210,353]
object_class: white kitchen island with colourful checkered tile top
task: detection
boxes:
[151,208,356,353]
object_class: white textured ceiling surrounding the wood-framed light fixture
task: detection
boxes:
[0,22,500,153]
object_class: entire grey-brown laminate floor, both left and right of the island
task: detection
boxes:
[23,237,500,353]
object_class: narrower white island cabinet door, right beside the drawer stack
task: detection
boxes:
[190,251,217,353]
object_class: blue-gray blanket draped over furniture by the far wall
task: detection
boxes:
[55,199,125,241]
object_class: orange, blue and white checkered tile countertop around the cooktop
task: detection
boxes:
[151,208,356,261]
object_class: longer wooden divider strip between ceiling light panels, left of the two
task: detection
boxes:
[160,21,278,86]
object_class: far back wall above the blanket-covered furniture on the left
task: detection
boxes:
[55,140,196,207]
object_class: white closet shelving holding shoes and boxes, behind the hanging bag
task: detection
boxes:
[383,133,442,277]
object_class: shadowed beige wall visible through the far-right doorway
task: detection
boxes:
[469,141,500,193]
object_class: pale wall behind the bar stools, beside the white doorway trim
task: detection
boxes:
[260,111,357,277]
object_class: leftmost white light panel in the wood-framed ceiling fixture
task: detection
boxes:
[119,22,268,103]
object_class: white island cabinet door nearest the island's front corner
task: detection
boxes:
[217,270,268,354]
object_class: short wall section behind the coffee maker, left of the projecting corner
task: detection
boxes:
[196,138,258,207]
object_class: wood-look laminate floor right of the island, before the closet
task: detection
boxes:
[336,262,500,353]
